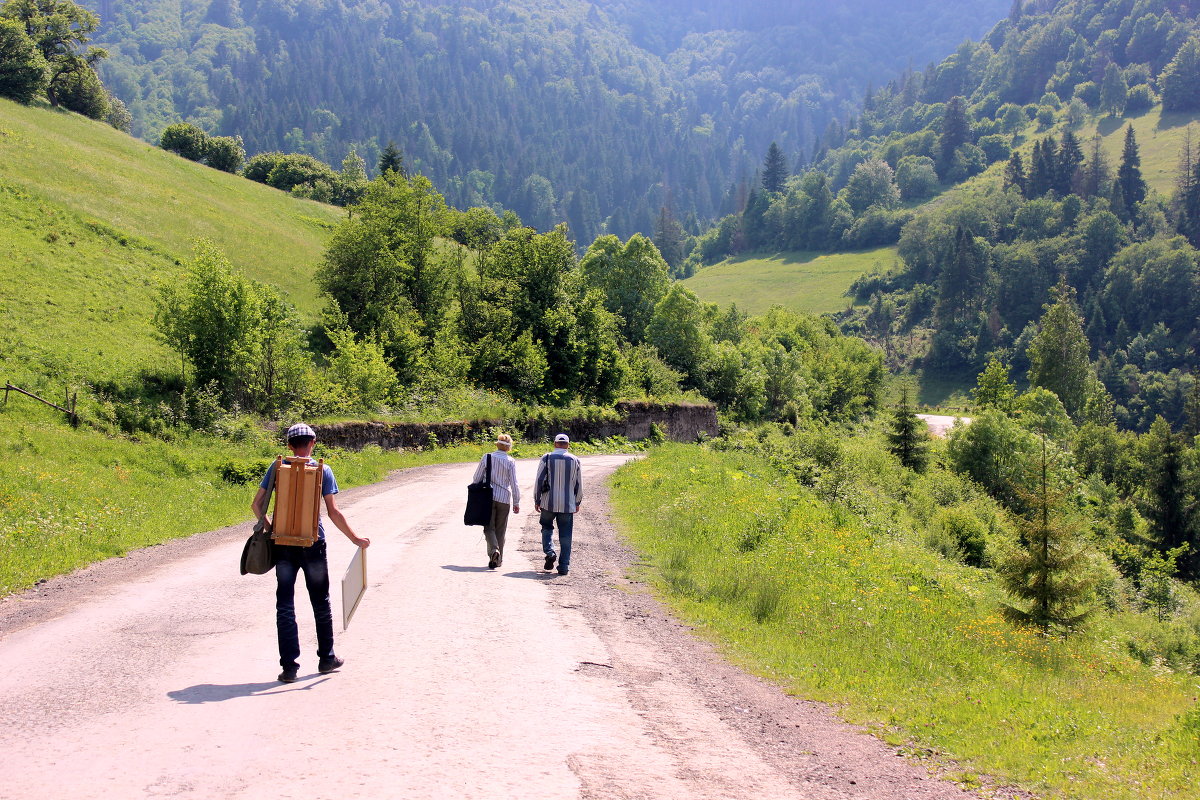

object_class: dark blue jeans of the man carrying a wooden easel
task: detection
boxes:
[275,540,334,669]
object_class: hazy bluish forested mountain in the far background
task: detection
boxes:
[82,0,1008,242]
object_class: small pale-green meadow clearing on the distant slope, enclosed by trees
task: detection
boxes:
[684,247,896,314]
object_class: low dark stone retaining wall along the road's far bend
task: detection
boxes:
[316,402,718,450]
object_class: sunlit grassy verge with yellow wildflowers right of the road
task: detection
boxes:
[613,445,1200,799]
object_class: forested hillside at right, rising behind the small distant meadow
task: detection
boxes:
[683,0,1200,431]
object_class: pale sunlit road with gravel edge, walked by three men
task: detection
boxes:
[0,456,1003,800]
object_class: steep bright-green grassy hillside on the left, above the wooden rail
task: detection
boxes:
[0,100,344,379]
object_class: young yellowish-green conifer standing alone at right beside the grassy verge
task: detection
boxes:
[996,435,1096,631]
